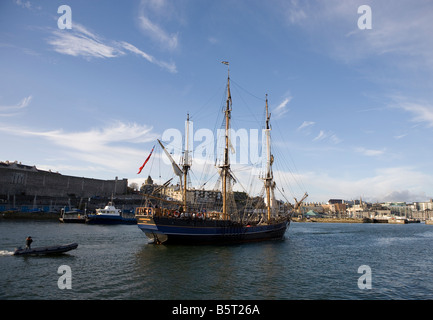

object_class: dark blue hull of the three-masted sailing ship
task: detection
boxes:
[138,217,290,244]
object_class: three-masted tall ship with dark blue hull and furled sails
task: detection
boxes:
[135,61,308,244]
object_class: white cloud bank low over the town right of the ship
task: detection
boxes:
[264,161,433,202]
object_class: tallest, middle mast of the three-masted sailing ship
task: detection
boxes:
[221,61,232,220]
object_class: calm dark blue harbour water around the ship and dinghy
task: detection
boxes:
[0,220,433,300]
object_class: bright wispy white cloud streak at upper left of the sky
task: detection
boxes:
[47,22,176,73]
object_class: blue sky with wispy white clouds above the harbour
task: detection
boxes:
[0,0,433,202]
